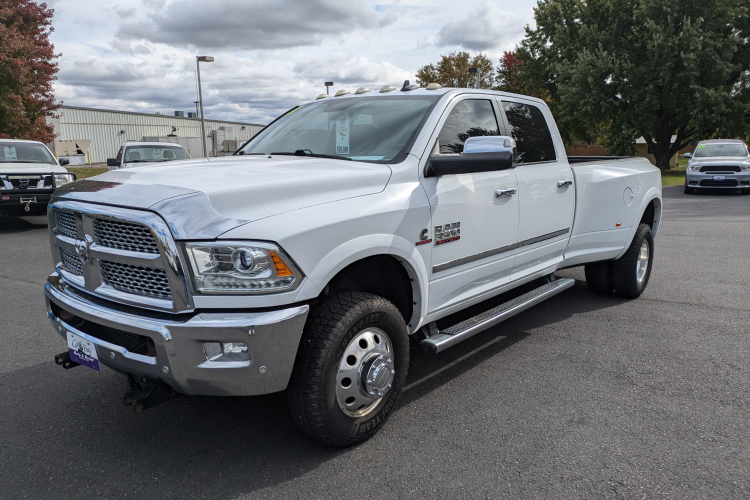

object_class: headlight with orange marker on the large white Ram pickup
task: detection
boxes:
[185,241,302,294]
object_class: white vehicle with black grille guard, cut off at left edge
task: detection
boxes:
[0,139,76,215]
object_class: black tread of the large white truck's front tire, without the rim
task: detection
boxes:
[287,292,409,447]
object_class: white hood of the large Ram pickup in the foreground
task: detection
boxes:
[55,155,391,234]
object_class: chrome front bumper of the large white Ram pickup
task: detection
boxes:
[44,273,309,396]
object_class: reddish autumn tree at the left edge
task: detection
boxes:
[0,0,60,143]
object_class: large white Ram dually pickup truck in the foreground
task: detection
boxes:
[45,85,662,446]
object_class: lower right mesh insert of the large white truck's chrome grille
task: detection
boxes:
[99,260,172,300]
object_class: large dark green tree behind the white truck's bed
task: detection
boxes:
[517,0,750,169]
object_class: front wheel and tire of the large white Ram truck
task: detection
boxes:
[287,292,409,447]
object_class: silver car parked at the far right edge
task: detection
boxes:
[685,139,750,194]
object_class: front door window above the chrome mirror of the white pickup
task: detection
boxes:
[438,99,500,154]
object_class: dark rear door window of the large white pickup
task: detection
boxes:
[503,102,557,163]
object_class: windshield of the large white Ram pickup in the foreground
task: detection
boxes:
[237,95,440,163]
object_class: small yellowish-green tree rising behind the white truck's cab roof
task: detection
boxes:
[417,51,495,89]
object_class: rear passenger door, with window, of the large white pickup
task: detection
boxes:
[501,98,576,280]
